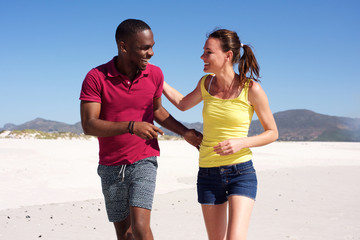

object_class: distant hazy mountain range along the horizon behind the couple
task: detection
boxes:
[0,109,360,142]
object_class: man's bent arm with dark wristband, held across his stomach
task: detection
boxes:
[80,101,163,139]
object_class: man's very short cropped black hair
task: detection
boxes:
[115,19,151,43]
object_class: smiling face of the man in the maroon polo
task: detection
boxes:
[127,30,155,70]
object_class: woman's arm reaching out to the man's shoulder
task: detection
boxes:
[163,80,202,111]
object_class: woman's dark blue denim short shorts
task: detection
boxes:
[197,160,257,205]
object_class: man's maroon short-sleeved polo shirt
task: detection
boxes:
[80,57,164,165]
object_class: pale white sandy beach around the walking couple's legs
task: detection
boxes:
[0,139,360,240]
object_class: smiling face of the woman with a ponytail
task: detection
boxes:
[201,38,227,73]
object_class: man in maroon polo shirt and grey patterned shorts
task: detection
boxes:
[80,19,202,239]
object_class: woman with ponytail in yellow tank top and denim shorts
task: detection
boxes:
[164,29,278,240]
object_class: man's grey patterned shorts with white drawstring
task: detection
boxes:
[98,157,158,222]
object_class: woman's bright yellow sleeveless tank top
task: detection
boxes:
[199,75,254,168]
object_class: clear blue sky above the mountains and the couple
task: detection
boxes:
[0,0,360,127]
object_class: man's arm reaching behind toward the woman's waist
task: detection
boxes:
[154,97,202,148]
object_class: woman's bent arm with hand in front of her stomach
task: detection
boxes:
[214,82,279,155]
